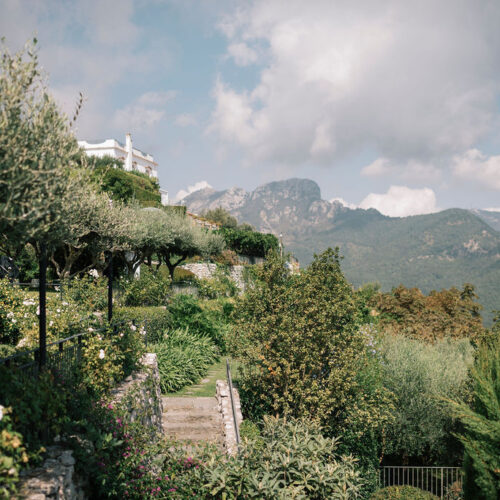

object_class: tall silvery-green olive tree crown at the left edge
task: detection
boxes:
[0,40,81,254]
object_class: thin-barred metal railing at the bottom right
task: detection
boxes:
[379,466,462,498]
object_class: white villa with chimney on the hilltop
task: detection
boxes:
[78,134,168,205]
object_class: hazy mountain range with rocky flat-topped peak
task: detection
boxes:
[183,179,500,320]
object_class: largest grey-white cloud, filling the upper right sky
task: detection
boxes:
[210,0,500,168]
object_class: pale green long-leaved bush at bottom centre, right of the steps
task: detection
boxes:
[203,417,362,500]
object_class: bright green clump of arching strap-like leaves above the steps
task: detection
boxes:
[153,329,219,393]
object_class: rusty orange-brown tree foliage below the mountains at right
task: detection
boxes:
[370,283,485,342]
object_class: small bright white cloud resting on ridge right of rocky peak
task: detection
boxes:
[359,186,438,217]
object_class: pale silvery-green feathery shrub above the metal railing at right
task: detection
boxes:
[381,335,473,465]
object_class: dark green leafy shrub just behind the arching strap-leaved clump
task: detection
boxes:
[168,295,226,354]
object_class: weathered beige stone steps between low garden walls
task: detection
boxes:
[162,397,224,450]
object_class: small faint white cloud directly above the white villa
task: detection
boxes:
[113,91,175,131]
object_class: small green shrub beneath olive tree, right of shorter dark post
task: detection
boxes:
[121,266,170,306]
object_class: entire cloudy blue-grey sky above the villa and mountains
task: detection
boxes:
[0,0,500,216]
